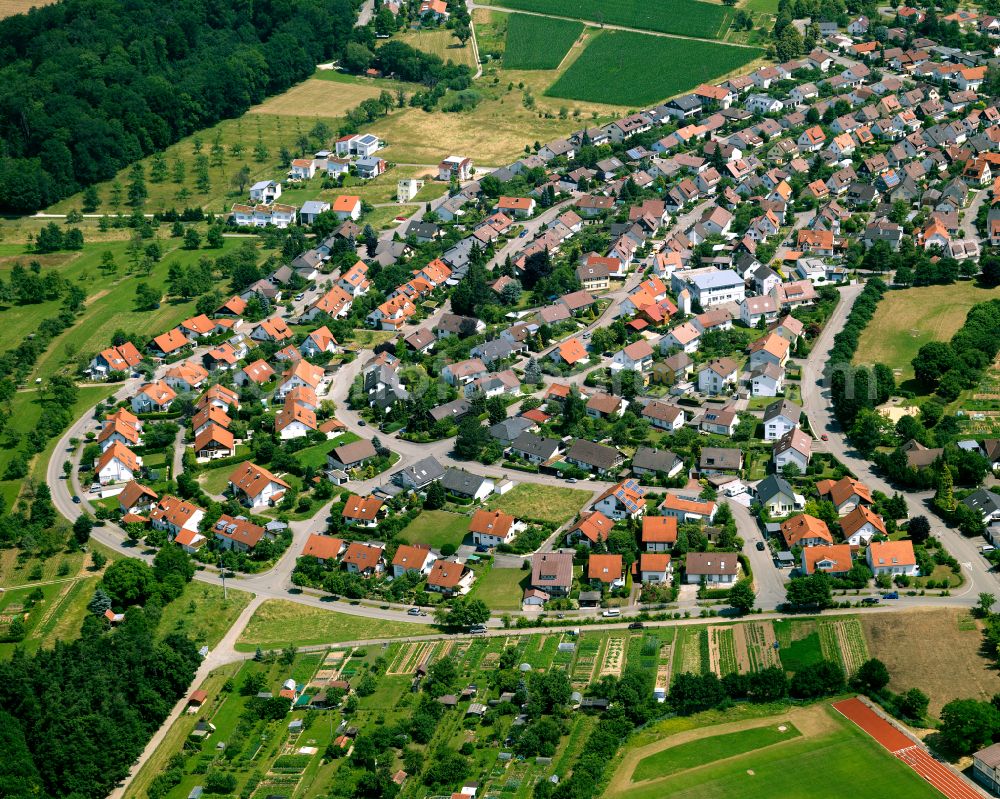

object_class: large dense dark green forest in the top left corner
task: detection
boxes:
[0,0,355,212]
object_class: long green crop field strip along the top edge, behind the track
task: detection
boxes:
[493,0,732,39]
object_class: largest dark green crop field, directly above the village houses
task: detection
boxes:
[546,31,761,107]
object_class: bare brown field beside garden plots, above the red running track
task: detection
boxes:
[861,608,1000,716]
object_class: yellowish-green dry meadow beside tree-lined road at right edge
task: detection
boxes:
[854,281,1000,382]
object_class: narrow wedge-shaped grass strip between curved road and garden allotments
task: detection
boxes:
[236,599,426,652]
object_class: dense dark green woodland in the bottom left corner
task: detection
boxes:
[0,608,200,799]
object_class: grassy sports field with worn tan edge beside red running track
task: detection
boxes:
[604,704,940,799]
